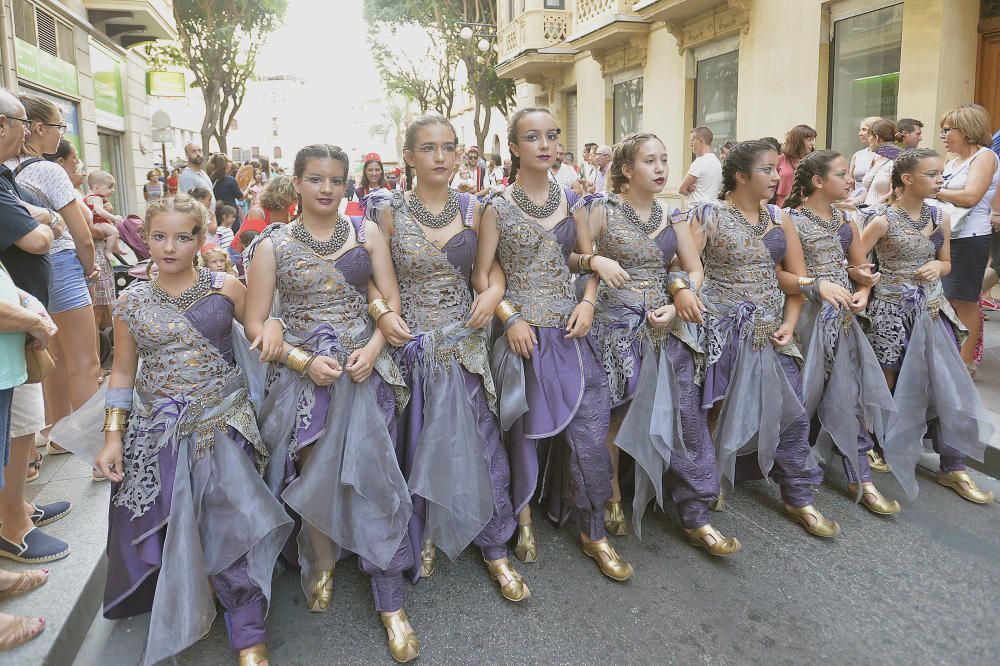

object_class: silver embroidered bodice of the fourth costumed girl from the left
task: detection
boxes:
[490,196,576,327]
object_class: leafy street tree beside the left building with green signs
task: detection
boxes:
[152,0,288,153]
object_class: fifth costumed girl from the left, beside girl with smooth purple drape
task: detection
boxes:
[586,134,740,556]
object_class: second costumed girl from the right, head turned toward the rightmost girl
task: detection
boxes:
[778,150,899,516]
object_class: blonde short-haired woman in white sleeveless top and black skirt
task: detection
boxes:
[938,105,1000,372]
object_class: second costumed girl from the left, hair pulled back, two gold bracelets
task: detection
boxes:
[246,144,419,661]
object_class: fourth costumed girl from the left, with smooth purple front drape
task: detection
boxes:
[473,109,632,581]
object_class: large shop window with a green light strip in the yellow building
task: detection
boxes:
[829,4,903,155]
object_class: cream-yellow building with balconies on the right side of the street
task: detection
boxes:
[497,0,1000,205]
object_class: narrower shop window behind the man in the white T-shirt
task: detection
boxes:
[691,51,740,150]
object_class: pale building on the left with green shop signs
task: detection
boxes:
[0,0,177,213]
